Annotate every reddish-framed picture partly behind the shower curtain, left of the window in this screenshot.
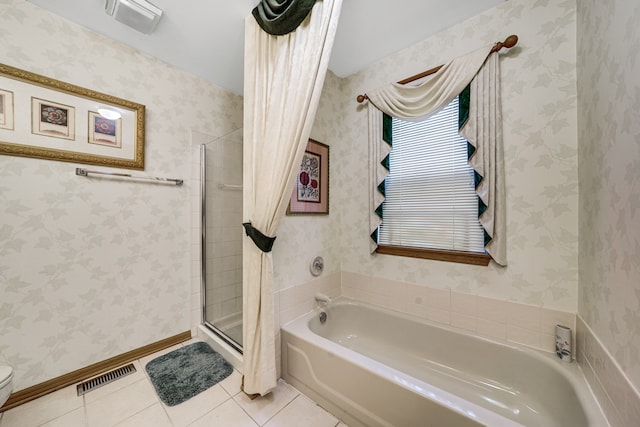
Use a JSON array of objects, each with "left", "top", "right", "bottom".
[{"left": 287, "top": 139, "right": 329, "bottom": 215}]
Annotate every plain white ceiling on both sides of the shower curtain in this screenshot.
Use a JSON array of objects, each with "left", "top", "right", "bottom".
[{"left": 29, "top": 0, "right": 506, "bottom": 94}]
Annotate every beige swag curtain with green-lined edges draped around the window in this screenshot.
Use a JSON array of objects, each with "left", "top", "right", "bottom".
[{"left": 367, "top": 45, "right": 506, "bottom": 265}]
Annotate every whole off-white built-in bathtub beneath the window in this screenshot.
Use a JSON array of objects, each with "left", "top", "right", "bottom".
[{"left": 282, "top": 298, "right": 608, "bottom": 427}]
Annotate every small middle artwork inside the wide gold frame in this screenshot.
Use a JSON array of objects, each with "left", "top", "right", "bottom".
[{"left": 31, "top": 97, "right": 76, "bottom": 141}]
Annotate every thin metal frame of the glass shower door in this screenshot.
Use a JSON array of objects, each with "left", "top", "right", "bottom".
[{"left": 200, "top": 144, "right": 243, "bottom": 354}]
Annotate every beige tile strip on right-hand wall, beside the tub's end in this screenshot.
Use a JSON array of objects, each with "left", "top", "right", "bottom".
[{"left": 576, "top": 316, "right": 640, "bottom": 427}]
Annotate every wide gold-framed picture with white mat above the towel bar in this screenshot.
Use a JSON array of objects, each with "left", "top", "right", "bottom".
[{"left": 0, "top": 64, "right": 145, "bottom": 170}]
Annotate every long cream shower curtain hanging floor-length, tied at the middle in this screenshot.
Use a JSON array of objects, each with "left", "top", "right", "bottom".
[{"left": 243, "top": 0, "right": 342, "bottom": 395}]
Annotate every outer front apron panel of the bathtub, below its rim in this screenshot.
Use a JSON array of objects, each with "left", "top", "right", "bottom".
[{"left": 282, "top": 331, "right": 488, "bottom": 427}]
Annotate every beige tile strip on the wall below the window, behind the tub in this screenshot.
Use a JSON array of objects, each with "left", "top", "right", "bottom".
[{"left": 341, "top": 272, "right": 576, "bottom": 352}]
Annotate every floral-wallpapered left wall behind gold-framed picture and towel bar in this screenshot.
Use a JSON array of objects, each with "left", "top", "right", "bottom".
[{"left": 0, "top": 0, "right": 242, "bottom": 390}]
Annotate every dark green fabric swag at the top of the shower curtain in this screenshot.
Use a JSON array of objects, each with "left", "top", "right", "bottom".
[{"left": 251, "top": 0, "right": 316, "bottom": 36}]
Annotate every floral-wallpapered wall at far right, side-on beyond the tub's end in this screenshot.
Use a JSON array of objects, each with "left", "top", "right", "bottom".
[{"left": 578, "top": 0, "right": 640, "bottom": 394}]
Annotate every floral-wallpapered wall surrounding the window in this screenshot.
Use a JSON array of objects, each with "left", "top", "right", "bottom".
[{"left": 308, "top": 0, "right": 578, "bottom": 312}]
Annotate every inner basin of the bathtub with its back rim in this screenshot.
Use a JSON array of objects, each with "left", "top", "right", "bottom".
[{"left": 283, "top": 298, "right": 606, "bottom": 426}]
